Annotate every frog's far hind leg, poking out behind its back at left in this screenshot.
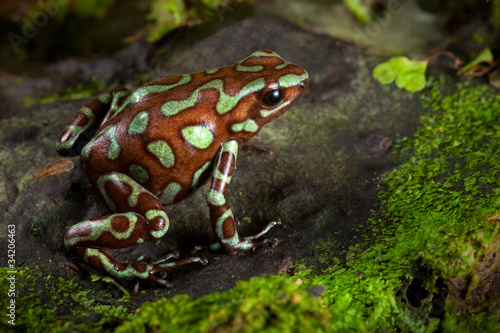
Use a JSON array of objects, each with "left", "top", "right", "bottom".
[{"left": 56, "top": 88, "right": 130, "bottom": 156}]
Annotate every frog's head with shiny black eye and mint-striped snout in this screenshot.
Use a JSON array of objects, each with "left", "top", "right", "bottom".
[{"left": 228, "top": 50, "right": 309, "bottom": 133}]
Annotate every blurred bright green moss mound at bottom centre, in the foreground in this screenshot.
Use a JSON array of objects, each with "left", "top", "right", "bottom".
[{"left": 116, "top": 276, "right": 329, "bottom": 332}]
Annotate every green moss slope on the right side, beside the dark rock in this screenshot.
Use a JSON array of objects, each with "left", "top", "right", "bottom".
[{"left": 299, "top": 77, "right": 500, "bottom": 332}]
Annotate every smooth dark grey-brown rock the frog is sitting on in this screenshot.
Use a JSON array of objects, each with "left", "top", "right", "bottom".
[{"left": 0, "top": 16, "right": 421, "bottom": 303}]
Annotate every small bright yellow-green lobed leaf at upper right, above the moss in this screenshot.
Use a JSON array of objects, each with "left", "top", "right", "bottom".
[{"left": 373, "top": 57, "right": 427, "bottom": 92}]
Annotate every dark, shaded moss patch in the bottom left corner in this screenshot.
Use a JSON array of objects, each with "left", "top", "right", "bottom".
[{"left": 0, "top": 267, "right": 135, "bottom": 332}]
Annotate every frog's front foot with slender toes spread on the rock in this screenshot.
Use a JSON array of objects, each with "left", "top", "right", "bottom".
[{"left": 191, "top": 219, "right": 281, "bottom": 254}]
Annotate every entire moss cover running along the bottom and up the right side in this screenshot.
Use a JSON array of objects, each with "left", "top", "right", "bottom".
[{"left": 1, "top": 79, "right": 500, "bottom": 332}]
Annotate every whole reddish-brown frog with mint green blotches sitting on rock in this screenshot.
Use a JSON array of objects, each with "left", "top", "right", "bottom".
[{"left": 56, "top": 50, "right": 309, "bottom": 287}]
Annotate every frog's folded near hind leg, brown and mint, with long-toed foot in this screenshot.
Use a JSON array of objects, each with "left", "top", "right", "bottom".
[{"left": 64, "top": 172, "right": 206, "bottom": 287}]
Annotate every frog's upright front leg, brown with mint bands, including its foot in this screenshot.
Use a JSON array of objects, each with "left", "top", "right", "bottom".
[{"left": 207, "top": 140, "right": 281, "bottom": 254}]
